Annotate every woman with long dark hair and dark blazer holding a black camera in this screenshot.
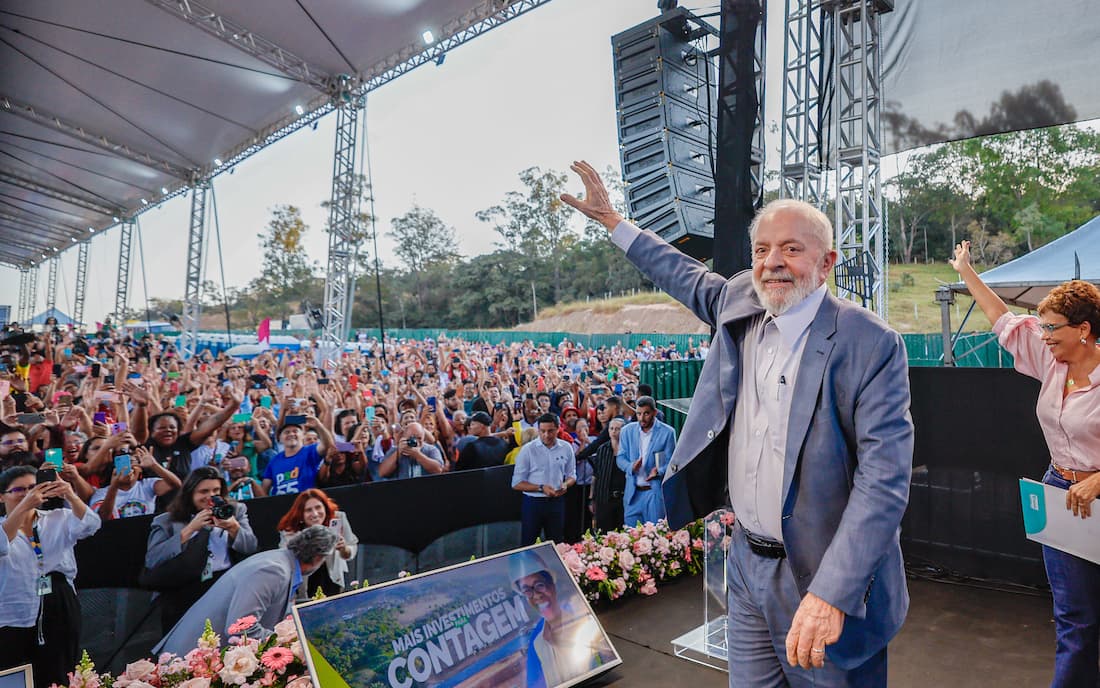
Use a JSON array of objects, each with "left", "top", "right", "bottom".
[{"left": 142, "top": 466, "right": 257, "bottom": 633}]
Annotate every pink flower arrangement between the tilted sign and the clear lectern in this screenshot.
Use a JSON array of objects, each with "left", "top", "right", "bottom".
[{"left": 558, "top": 518, "right": 705, "bottom": 601}]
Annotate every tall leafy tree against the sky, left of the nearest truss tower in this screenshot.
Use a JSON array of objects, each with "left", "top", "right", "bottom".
[{"left": 251, "top": 205, "right": 316, "bottom": 318}]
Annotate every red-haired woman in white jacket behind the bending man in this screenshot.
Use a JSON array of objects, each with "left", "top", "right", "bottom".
[{"left": 278, "top": 488, "right": 359, "bottom": 600}]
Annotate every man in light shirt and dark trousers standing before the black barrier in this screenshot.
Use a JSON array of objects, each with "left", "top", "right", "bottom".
[{"left": 512, "top": 413, "right": 576, "bottom": 546}]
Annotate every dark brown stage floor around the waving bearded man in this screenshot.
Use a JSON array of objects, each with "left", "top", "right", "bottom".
[{"left": 592, "top": 577, "right": 1054, "bottom": 688}]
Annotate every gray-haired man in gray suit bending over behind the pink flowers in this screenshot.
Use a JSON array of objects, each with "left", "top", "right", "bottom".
[{"left": 153, "top": 525, "right": 337, "bottom": 657}]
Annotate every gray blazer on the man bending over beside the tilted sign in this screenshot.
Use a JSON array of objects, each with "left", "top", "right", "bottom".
[{"left": 153, "top": 549, "right": 298, "bottom": 657}]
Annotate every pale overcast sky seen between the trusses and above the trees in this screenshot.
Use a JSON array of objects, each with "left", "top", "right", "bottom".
[{"left": 0, "top": 0, "right": 818, "bottom": 323}]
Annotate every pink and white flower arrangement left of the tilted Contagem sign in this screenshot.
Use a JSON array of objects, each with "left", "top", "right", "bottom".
[{"left": 52, "top": 615, "right": 314, "bottom": 688}]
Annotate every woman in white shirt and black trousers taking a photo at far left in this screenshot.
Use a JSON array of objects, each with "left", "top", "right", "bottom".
[{"left": 0, "top": 466, "right": 100, "bottom": 688}]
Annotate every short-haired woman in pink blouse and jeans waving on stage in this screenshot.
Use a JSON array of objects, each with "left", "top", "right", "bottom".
[{"left": 950, "top": 241, "right": 1100, "bottom": 687}]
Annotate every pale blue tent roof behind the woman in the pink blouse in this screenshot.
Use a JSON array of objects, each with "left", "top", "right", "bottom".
[{"left": 950, "top": 216, "right": 1100, "bottom": 308}]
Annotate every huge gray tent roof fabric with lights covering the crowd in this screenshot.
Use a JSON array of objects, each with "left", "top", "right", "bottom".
[{"left": 0, "top": 0, "right": 549, "bottom": 266}]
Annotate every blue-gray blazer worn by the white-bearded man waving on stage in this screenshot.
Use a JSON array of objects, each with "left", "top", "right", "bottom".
[{"left": 627, "top": 224, "right": 913, "bottom": 668}]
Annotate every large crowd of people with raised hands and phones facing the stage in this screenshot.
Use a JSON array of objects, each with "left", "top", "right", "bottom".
[{"left": 0, "top": 326, "right": 706, "bottom": 685}]
